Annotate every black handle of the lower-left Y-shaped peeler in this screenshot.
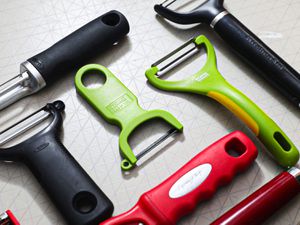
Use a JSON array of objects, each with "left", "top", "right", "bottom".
[{"left": 24, "top": 135, "right": 113, "bottom": 225}]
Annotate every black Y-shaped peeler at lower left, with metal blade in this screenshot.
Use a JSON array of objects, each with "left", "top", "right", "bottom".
[{"left": 0, "top": 101, "right": 113, "bottom": 225}]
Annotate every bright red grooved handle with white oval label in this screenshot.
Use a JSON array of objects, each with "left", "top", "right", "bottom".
[{"left": 147, "top": 132, "right": 257, "bottom": 224}]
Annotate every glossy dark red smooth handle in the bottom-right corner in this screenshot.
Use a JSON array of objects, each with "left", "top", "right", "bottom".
[{"left": 211, "top": 172, "right": 300, "bottom": 225}]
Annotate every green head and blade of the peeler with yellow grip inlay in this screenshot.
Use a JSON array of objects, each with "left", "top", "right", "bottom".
[{"left": 146, "top": 35, "right": 224, "bottom": 95}]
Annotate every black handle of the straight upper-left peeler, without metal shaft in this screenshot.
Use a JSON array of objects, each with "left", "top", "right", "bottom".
[{"left": 27, "top": 10, "right": 129, "bottom": 84}]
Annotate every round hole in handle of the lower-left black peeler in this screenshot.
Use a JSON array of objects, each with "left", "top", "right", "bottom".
[{"left": 73, "top": 191, "right": 97, "bottom": 214}]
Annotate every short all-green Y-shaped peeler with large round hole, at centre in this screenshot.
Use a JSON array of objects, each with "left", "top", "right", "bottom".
[{"left": 75, "top": 64, "right": 183, "bottom": 171}]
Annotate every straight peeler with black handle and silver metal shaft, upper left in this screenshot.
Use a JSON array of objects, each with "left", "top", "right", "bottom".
[{"left": 0, "top": 10, "right": 129, "bottom": 110}]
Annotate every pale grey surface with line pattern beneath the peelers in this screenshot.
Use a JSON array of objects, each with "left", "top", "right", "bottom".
[{"left": 0, "top": 0, "right": 300, "bottom": 225}]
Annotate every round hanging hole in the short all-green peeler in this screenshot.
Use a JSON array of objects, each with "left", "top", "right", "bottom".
[{"left": 81, "top": 70, "right": 106, "bottom": 88}]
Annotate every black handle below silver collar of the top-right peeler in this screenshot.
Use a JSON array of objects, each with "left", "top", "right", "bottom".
[{"left": 214, "top": 14, "right": 300, "bottom": 107}]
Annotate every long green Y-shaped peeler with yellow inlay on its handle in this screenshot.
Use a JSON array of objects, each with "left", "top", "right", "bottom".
[{"left": 146, "top": 35, "right": 299, "bottom": 167}]
